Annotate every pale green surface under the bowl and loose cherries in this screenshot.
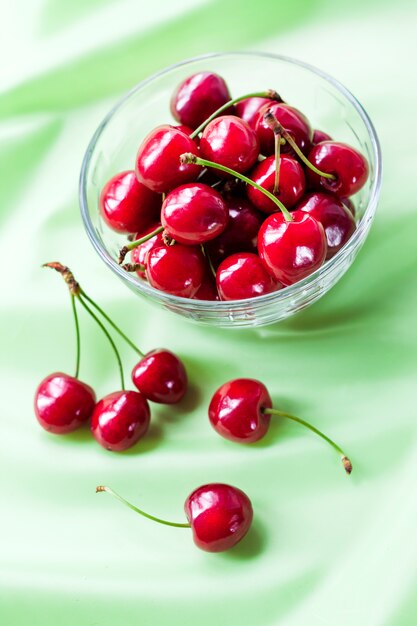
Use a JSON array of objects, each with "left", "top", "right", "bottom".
[{"left": 0, "top": 0, "right": 417, "bottom": 626}]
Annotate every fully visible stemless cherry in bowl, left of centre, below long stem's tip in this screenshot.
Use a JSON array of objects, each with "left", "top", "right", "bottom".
[{"left": 161, "top": 183, "right": 229, "bottom": 245}]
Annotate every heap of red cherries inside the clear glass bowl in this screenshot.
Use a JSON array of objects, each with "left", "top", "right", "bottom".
[{"left": 99, "top": 72, "right": 368, "bottom": 300}]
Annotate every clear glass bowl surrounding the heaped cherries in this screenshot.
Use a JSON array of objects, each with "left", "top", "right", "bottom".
[{"left": 80, "top": 52, "right": 381, "bottom": 328}]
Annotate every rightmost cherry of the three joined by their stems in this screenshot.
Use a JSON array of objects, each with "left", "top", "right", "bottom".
[{"left": 132, "top": 349, "right": 188, "bottom": 404}]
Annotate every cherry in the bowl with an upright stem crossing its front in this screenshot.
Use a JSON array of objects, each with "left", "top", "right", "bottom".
[{"left": 246, "top": 154, "right": 306, "bottom": 213}]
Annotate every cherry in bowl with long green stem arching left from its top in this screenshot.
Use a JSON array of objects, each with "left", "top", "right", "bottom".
[{"left": 258, "top": 211, "right": 327, "bottom": 285}]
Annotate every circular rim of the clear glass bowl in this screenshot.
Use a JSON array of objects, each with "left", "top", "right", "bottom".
[{"left": 79, "top": 51, "right": 382, "bottom": 313}]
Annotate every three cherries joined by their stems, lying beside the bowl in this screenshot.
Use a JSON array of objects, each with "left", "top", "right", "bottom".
[{"left": 35, "top": 262, "right": 188, "bottom": 451}]
